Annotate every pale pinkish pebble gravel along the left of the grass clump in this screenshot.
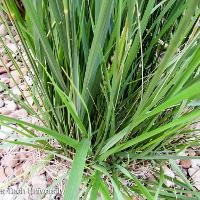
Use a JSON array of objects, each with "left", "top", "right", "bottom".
[{"left": 0, "top": 20, "right": 67, "bottom": 200}]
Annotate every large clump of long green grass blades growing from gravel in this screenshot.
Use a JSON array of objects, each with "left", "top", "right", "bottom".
[{"left": 0, "top": 0, "right": 200, "bottom": 200}]
